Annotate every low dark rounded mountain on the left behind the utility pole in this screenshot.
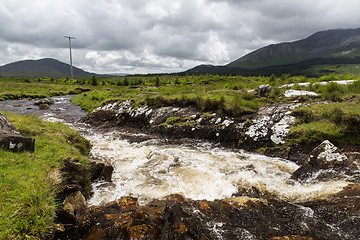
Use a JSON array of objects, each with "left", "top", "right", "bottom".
[{"left": 0, "top": 58, "right": 103, "bottom": 78}]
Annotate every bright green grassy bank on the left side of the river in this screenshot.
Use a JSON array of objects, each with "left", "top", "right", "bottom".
[{"left": 0, "top": 113, "right": 90, "bottom": 239}]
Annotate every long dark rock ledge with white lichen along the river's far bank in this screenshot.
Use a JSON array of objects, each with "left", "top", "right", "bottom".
[{"left": 83, "top": 101, "right": 299, "bottom": 150}]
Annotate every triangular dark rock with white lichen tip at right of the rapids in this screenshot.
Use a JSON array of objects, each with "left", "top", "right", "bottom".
[{"left": 291, "top": 140, "right": 359, "bottom": 181}]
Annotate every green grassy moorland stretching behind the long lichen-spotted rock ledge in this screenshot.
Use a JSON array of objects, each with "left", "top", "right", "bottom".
[{"left": 73, "top": 75, "right": 359, "bottom": 115}]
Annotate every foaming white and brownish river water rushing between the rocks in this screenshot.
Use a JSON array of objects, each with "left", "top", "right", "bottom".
[{"left": 0, "top": 96, "right": 348, "bottom": 205}]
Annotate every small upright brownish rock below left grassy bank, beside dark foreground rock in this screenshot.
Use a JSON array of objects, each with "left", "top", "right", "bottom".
[{"left": 59, "top": 191, "right": 88, "bottom": 223}]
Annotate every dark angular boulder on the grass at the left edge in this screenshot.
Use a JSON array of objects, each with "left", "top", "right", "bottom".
[{"left": 0, "top": 113, "right": 35, "bottom": 152}]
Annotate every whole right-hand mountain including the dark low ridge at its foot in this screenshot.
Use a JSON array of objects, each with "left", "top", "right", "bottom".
[{"left": 188, "top": 28, "right": 360, "bottom": 74}]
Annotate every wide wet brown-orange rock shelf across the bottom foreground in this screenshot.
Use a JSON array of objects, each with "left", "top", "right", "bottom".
[{"left": 57, "top": 191, "right": 360, "bottom": 240}]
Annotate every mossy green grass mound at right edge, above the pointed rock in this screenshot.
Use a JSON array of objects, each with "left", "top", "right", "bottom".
[{"left": 288, "top": 101, "right": 360, "bottom": 145}]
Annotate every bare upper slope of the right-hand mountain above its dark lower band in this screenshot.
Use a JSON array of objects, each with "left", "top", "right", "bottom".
[{"left": 226, "top": 28, "right": 360, "bottom": 69}]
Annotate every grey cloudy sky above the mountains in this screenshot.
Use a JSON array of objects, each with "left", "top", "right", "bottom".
[{"left": 0, "top": 0, "right": 360, "bottom": 73}]
